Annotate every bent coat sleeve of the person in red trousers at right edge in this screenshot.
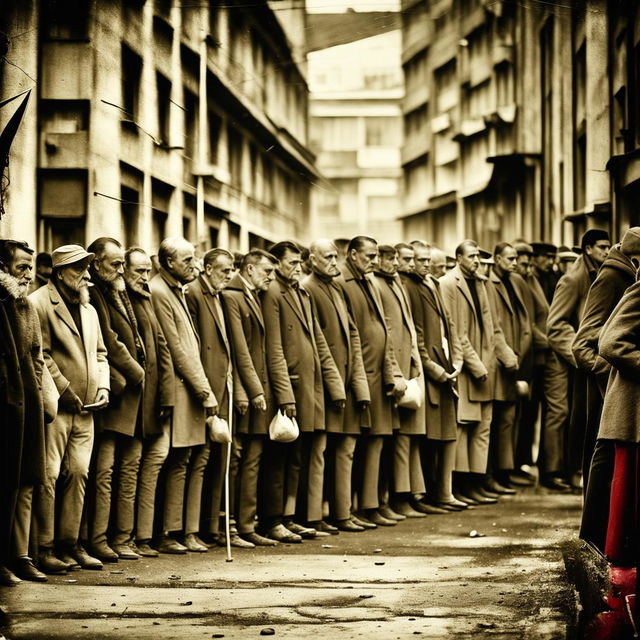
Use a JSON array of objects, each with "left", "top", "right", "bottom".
[{"left": 598, "top": 284, "right": 640, "bottom": 379}]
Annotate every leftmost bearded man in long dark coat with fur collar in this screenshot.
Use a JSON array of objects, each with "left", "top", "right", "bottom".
[{"left": 0, "top": 240, "right": 47, "bottom": 586}]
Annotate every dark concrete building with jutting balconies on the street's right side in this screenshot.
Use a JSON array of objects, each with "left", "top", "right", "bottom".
[{"left": 402, "top": 0, "right": 640, "bottom": 249}]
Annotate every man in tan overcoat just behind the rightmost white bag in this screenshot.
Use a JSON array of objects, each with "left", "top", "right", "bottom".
[{"left": 370, "top": 245, "right": 426, "bottom": 518}]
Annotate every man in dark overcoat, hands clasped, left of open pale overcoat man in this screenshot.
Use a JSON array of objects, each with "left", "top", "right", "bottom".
[{"left": 401, "top": 241, "right": 463, "bottom": 513}]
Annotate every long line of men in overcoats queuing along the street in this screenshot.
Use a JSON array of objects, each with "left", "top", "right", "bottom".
[{"left": 0, "top": 230, "right": 626, "bottom": 585}]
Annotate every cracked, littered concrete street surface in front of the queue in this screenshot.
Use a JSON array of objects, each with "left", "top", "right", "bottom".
[{"left": 0, "top": 489, "right": 581, "bottom": 640}]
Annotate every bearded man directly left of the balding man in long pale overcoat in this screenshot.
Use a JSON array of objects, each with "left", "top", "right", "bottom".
[{"left": 124, "top": 247, "right": 175, "bottom": 558}]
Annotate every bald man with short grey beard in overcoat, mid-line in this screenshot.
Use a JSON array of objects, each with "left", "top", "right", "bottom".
[{"left": 302, "top": 240, "right": 370, "bottom": 531}]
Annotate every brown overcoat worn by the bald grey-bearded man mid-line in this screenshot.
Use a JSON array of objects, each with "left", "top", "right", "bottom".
[{"left": 302, "top": 273, "right": 371, "bottom": 435}]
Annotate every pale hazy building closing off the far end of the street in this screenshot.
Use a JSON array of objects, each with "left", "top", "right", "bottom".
[{"left": 308, "top": 12, "right": 403, "bottom": 242}]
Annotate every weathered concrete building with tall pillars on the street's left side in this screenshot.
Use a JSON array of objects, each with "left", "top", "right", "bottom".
[{"left": 0, "top": 0, "right": 316, "bottom": 252}]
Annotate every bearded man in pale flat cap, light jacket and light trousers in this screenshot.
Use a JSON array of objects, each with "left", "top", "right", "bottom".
[{"left": 29, "top": 245, "right": 109, "bottom": 573}]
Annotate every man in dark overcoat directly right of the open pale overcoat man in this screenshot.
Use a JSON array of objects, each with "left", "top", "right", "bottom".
[{"left": 488, "top": 242, "right": 533, "bottom": 490}]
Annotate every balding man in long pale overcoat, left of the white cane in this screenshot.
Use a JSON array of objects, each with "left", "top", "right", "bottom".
[{"left": 150, "top": 238, "right": 218, "bottom": 553}]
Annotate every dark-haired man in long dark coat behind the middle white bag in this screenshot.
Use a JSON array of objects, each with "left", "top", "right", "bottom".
[{"left": 262, "top": 241, "right": 346, "bottom": 540}]
